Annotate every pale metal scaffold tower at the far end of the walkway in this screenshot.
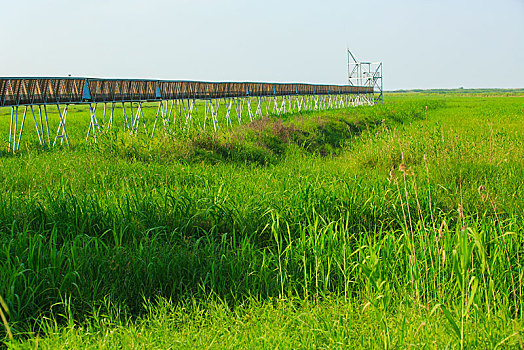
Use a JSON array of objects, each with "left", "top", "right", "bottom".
[{"left": 347, "top": 49, "right": 384, "bottom": 104}]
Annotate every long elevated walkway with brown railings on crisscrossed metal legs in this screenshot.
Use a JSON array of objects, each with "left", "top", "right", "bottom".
[{"left": 0, "top": 78, "right": 376, "bottom": 152}]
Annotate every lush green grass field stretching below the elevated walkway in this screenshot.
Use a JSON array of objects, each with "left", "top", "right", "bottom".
[{"left": 0, "top": 93, "right": 524, "bottom": 349}]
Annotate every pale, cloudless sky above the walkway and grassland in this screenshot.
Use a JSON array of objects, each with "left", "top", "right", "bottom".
[{"left": 0, "top": 0, "right": 524, "bottom": 90}]
